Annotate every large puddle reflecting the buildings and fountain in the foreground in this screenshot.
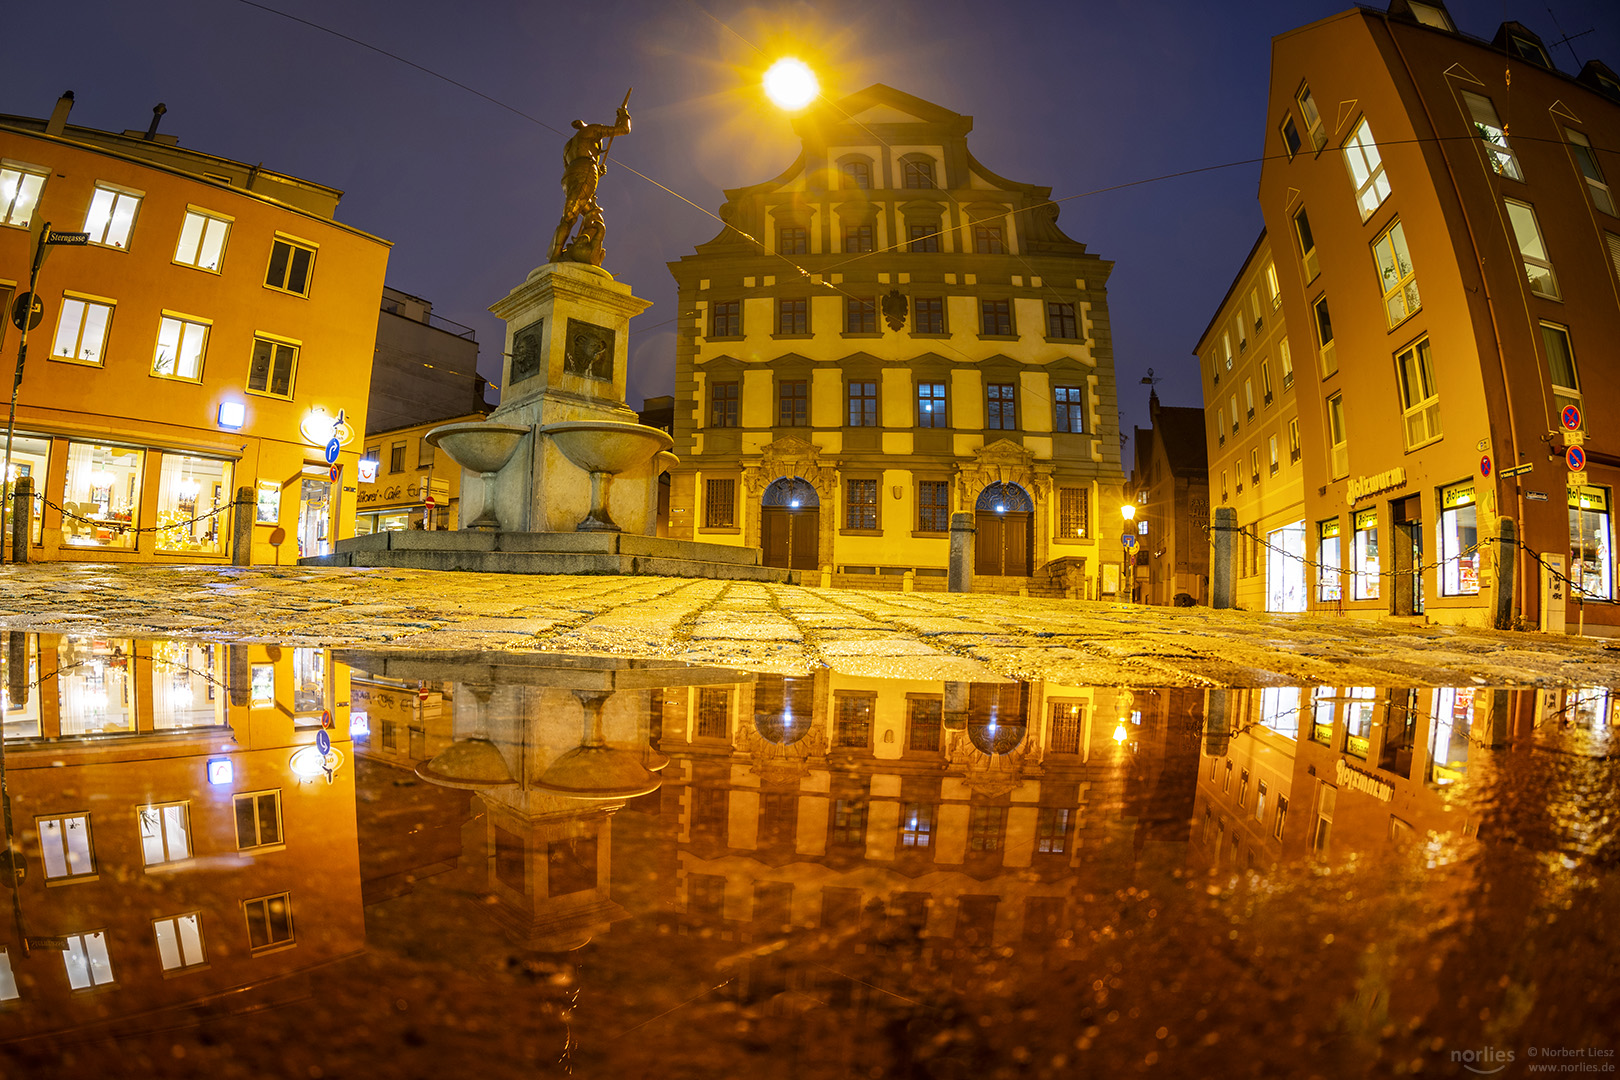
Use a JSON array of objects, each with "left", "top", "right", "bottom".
[{"left": 0, "top": 633, "right": 1620, "bottom": 1080}]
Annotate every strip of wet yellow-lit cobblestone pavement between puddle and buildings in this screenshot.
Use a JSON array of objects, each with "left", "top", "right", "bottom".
[{"left": 0, "top": 563, "right": 1620, "bottom": 687}]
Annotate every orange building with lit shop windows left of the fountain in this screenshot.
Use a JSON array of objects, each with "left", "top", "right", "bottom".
[{"left": 0, "top": 96, "right": 389, "bottom": 563}]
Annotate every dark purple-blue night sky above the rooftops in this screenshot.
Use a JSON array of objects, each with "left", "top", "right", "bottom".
[{"left": 0, "top": 0, "right": 1620, "bottom": 453}]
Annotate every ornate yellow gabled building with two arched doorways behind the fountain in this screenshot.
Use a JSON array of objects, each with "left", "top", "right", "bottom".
[{"left": 669, "top": 86, "right": 1124, "bottom": 596}]
